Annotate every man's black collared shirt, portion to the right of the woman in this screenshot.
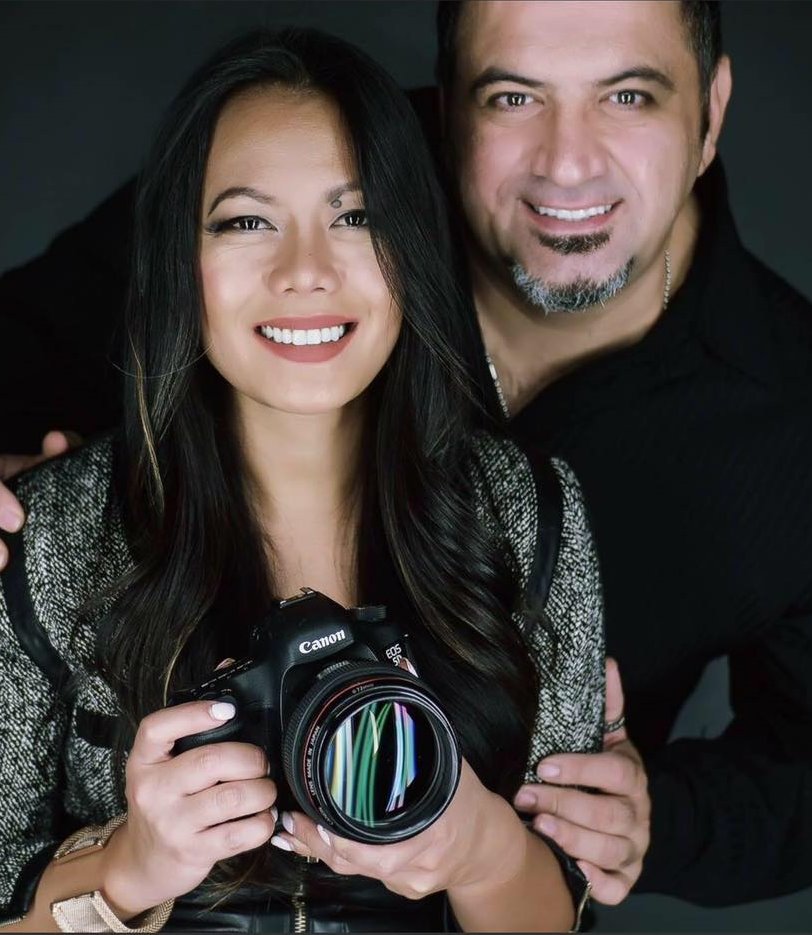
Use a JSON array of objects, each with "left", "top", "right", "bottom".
[{"left": 504, "top": 166, "right": 812, "bottom": 905}]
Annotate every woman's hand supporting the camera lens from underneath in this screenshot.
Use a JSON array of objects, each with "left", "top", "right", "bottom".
[{"left": 272, "top": 761, "right": 529, "bottom": 900}]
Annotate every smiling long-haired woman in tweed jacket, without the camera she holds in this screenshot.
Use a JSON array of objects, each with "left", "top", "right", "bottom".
[{"left": 0, "top": 32, "right": 603, "bottom": 931}]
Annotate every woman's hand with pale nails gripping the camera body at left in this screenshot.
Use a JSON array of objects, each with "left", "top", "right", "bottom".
[{"left": 102, "top": 701, "right": 276, "bottom": 918}]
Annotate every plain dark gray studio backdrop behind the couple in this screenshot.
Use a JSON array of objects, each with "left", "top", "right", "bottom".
[{"left": 0, "top": 0, "right": 812, "bottom": 932}]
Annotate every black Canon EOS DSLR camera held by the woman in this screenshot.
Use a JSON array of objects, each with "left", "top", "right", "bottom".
[{"left": 170, "top": 588, "right": 461, "bottom": 844}]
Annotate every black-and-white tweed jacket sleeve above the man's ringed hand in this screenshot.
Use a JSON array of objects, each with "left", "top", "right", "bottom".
[{"left": 473, "top": 432, "right": 604, "bottom": 768}]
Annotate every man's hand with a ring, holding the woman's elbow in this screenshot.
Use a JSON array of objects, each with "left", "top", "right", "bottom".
[{"left": 514, "top": 659, "right": 651, "bottom": 906}]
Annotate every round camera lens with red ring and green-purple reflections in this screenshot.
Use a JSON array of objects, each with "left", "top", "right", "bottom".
[{"left": 283, "top": 662, "right": 460, "bottom": 844}]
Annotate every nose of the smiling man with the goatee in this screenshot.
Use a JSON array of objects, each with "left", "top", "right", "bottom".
[{"left": 532, "top": 107, "right": 606, "bottom": 188}]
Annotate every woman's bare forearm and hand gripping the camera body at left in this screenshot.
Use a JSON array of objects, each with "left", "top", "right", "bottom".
[{"left": 3, "top": 701, "right": 276, "bottom": 932}]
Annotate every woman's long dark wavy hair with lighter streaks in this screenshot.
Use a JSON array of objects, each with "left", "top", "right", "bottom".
[{"left": 100, "top": 30, "right": 537, "bottom": 892}]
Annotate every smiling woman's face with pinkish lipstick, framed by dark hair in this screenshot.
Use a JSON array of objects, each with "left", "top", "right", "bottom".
[{"left": 200, "top": 88, "right": 401, "bottom": 414}]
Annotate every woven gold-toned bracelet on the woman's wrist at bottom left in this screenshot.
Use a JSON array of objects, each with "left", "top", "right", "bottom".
[{"left": 51, "top": 814, "right": 175, "bottom": 933}]
